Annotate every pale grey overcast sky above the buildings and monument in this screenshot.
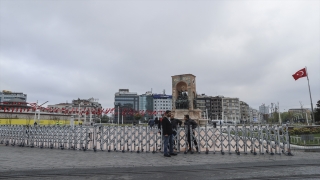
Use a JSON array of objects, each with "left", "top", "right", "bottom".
[{"left": 0, "top": 0, "right": 320, "bottom": 111}]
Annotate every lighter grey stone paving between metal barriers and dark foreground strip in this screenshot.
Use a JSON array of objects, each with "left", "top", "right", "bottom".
[{"left": 0, "top": 145, "right": 320, "bottom": 172}]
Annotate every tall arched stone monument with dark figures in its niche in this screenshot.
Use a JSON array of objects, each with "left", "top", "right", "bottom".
[{"left": 171, "top": 74, "right": 207, "bottom": 125}]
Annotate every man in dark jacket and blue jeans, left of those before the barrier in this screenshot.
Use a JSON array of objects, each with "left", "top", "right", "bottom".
[{"left": 162, "top": 110, "right": 177, "bottom": 157}]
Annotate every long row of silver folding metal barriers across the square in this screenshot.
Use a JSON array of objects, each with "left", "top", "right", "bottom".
[{"left": 0, "top": 125, "right": 291, "bottom": 155}]
